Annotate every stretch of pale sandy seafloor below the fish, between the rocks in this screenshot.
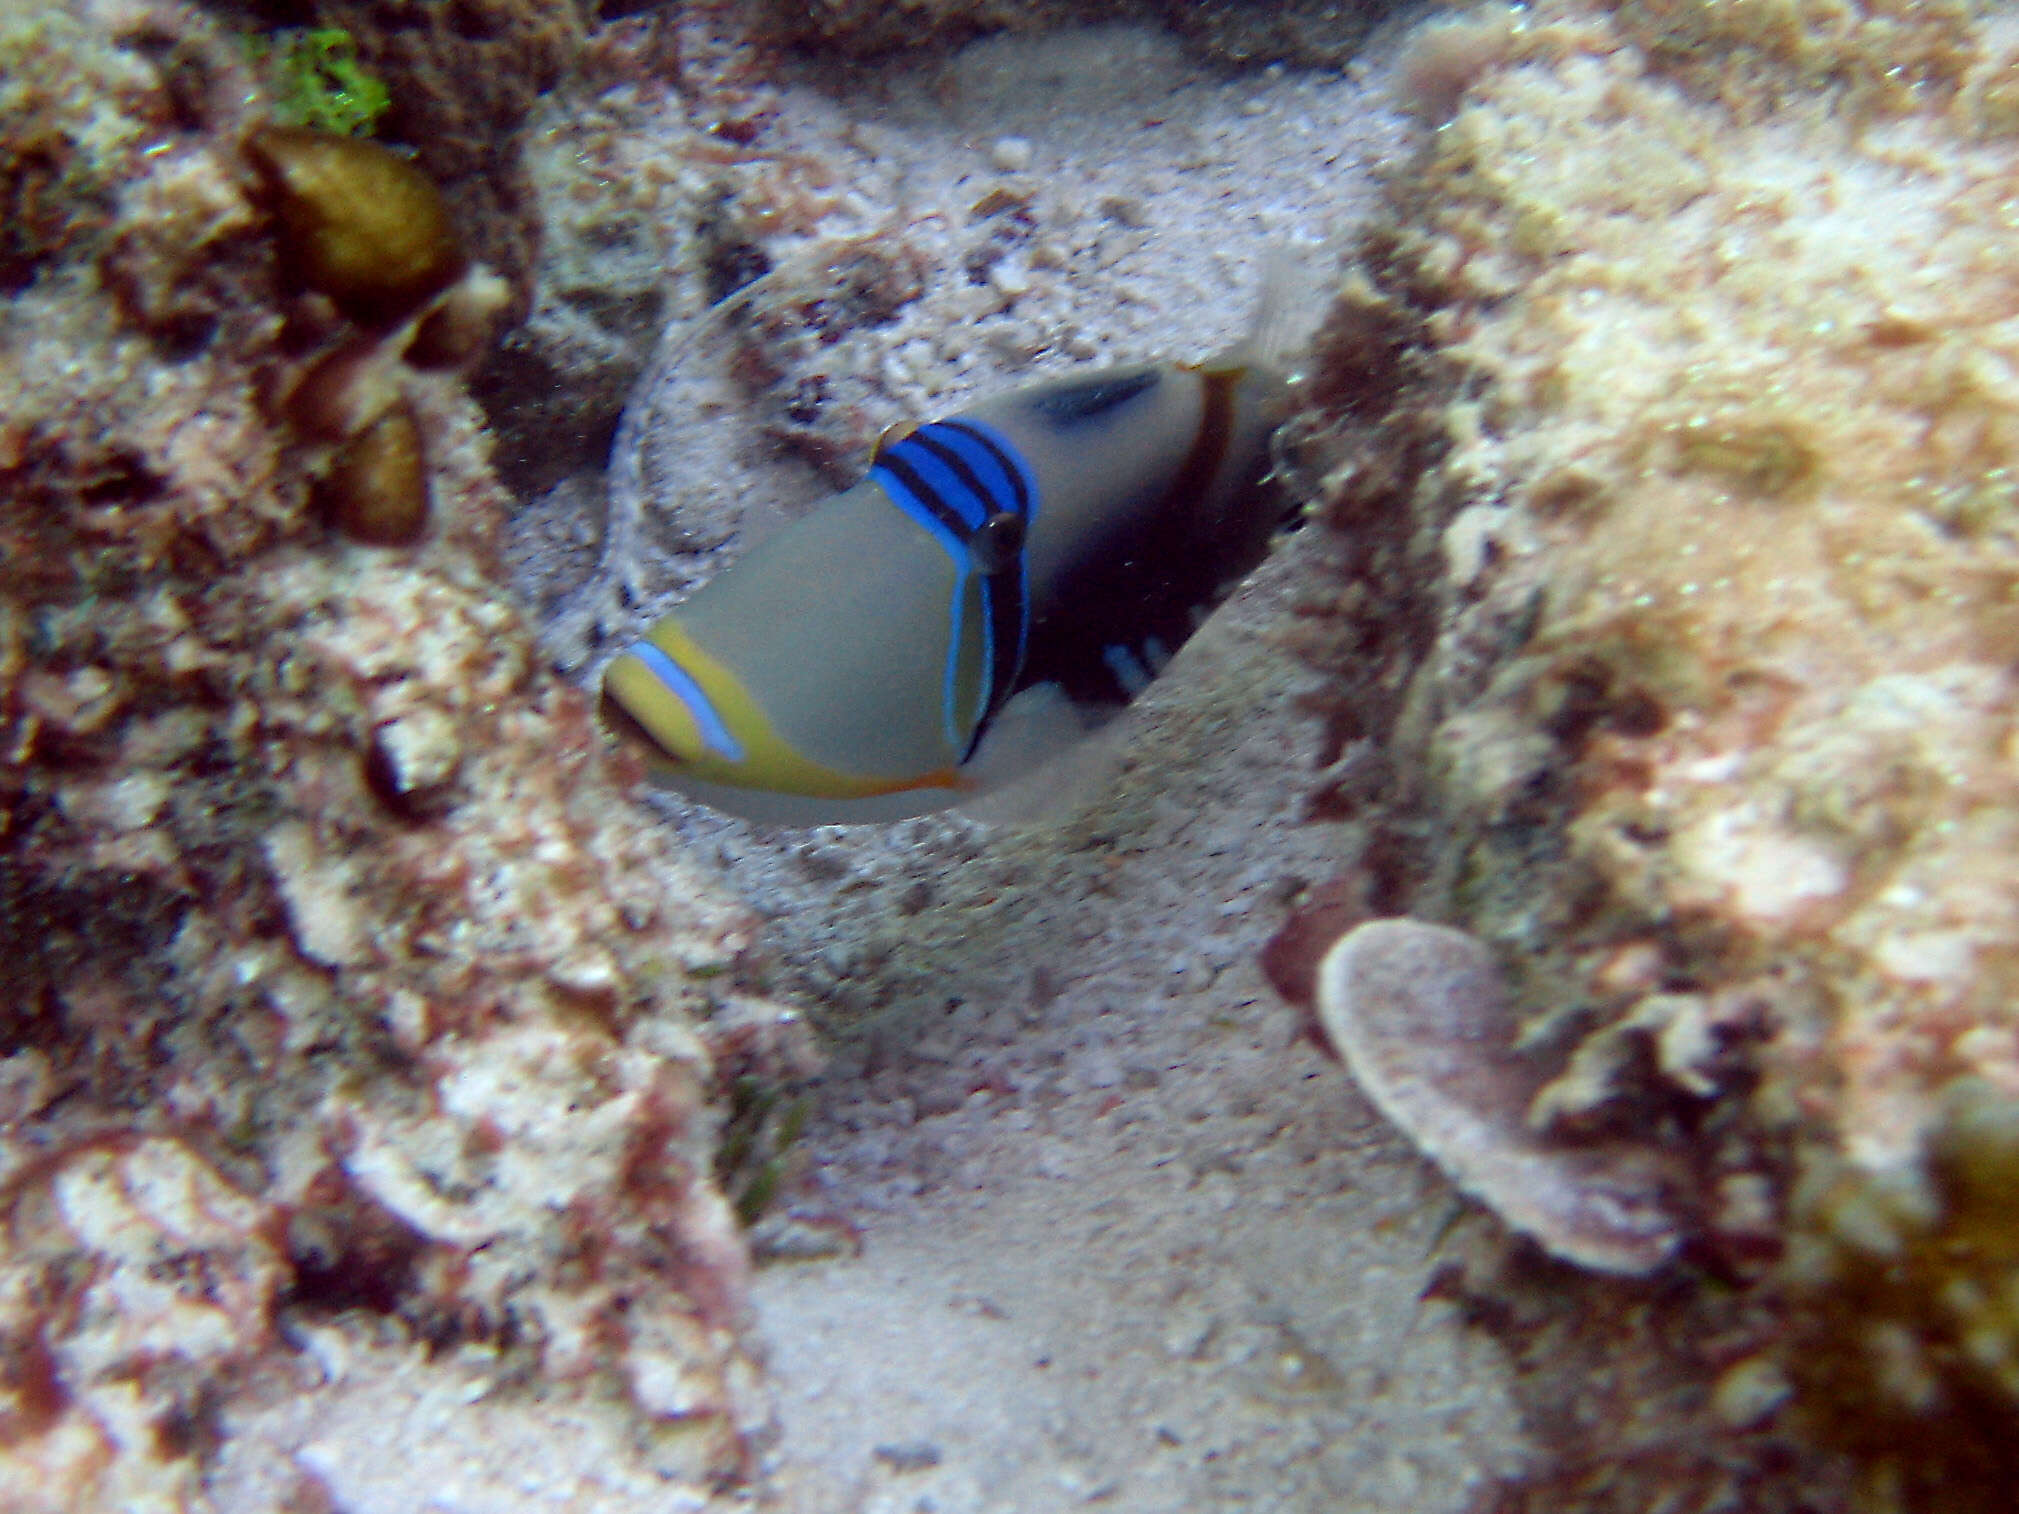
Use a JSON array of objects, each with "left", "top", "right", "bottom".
[{"left": 735, "top": 569, "right": 1518, "bottom": 1510}]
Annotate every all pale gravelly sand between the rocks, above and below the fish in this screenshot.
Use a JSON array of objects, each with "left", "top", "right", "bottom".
[{"left": 517, "top": 30, "right": 1524, "bottom": 1514}]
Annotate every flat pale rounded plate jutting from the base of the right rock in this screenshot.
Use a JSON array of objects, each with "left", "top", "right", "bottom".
[{"left": 1318, "top": 918, "right": 1682, "bottom": 1276}]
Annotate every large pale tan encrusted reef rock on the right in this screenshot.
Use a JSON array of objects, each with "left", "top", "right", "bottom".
[{"left": 1300, "top": 0, "right": 2019, "bottom": 1510}]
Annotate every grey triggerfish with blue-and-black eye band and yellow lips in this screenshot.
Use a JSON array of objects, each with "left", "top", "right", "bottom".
[{"left": 604, "top": 299, "right": 1286, "bottom": 826}]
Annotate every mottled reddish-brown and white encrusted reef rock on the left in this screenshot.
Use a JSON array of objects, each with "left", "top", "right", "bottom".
[{"left": 0, "top": 0, "right": 798, "bottom": 1510}]
